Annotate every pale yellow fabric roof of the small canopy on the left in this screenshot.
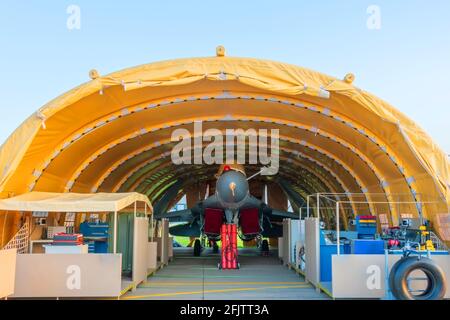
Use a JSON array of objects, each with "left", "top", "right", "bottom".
[{"left": 0, "top": 192, "right": 152, "bottom": 214}]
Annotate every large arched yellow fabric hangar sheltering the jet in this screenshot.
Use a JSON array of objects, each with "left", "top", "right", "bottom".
[{"left": 0, "top": 49, "right": 450, "bottom": 245}]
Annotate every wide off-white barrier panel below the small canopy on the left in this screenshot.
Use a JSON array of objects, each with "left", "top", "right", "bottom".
[{"left": 12, "top": 254, "right": 122, "bottom": 298}]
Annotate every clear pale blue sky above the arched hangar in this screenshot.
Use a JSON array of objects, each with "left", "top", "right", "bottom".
[{"left": 0, "top": 0, "right": 450, "bottom": 153}]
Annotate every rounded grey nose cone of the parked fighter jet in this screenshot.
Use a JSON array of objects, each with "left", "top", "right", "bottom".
[{"left": 216, "top": 171, "right": 248, "bottom": 207}]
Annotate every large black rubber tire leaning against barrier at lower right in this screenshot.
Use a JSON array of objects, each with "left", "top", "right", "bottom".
[{"left": 389, "top": 257, "right": 447, "bottom": 300}]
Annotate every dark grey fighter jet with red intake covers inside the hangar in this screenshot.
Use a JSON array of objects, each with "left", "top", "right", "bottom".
[{"left": 155, "top": 165, "right": 299, "bottom": 256}]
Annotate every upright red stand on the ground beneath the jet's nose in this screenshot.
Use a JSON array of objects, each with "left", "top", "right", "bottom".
[{"left": 219, "top": 224, "right": 239, "bottom": 269}]
